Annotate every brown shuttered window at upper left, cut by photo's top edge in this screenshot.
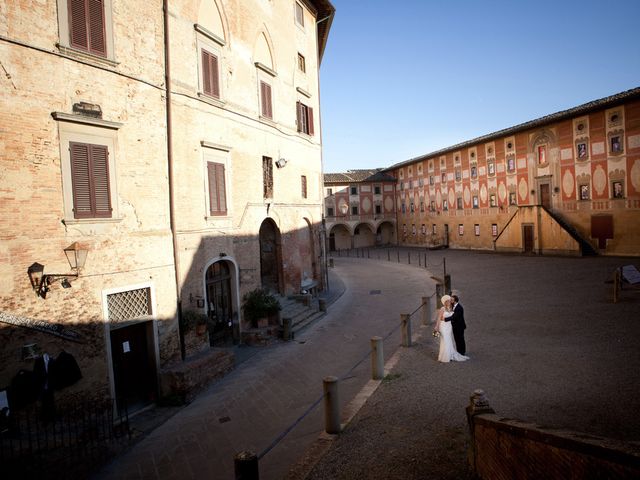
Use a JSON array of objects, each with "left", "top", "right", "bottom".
[{"left": 67, "top": 0, "right": 107, "bottom": 57}]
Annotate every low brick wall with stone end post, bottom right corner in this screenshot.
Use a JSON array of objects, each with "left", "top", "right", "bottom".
[{"left": 467, "top": 391, "right": 640, "bottom": 480}]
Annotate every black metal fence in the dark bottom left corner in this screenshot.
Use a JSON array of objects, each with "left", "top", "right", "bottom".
[{"left": 0, "top": 399, "right": 131, "bottom": 479}]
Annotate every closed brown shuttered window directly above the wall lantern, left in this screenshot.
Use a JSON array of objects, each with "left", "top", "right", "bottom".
[{"left": 69, "top": 142, "right": 111, "bottom": 218}]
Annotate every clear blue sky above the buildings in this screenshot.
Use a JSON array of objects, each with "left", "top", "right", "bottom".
[{"left": 320, "top": 0, "right": 640, "bottom": 173}]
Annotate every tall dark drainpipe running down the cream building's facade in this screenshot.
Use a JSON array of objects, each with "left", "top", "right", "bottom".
[{"left": 162, "top": 0, "right": 185, "bottom": 360}]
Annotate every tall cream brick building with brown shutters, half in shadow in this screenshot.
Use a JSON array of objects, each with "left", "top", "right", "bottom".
[{"left": 0, "top": 0, "right": 334, "bottom": 408}]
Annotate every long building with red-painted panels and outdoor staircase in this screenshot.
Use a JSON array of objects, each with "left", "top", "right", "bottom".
[{"left": 384, "top": 88, "right": 640, "bottom": 255}]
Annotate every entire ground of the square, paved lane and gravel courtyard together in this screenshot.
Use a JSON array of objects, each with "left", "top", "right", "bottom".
[{"left": 97, "top": 250, "right": 640, "bottom": 480}]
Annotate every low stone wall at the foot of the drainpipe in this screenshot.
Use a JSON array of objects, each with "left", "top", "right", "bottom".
[{"left": 160, "top": 349, "right": 235, "bottom": 403}]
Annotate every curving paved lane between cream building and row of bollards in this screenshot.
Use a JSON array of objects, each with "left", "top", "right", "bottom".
[{"left": 96, "top": 255, "right": 434, "bottom": 480}]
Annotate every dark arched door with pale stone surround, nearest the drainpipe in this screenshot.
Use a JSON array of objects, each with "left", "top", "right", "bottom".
[{"left": 205, "top": 261, "right": 234, "bottom": 346}]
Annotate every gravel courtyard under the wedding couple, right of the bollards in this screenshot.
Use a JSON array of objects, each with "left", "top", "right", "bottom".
[{"left": 302, "top": 251, "right": 640, "bottom": 480}]
